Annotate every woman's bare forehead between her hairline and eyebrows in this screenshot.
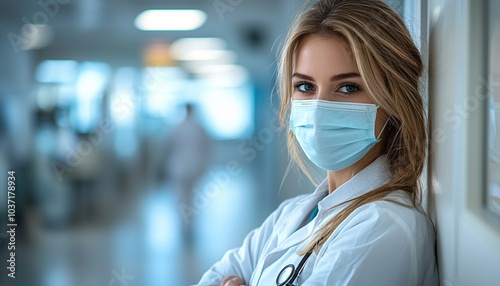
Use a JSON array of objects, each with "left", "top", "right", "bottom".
[{"left": 294, "top": 34, "right": 358, "bottom": 77}]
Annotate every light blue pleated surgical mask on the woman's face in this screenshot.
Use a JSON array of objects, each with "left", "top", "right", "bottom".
[{"left": 290, "top": 100, "right": 387, "bottom": 171}]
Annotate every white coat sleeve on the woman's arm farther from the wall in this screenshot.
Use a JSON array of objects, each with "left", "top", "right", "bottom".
[{"left": 197, "top": 197, "right": 296, "bottom": 286}]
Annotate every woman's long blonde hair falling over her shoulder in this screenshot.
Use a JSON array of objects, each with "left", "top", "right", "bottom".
[{"left": 278, "top": 0, "right": 427, "bottom": 254}]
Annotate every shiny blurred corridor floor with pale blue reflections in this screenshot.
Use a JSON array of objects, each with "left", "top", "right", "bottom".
[{"left": 2, "top": 167, "right": 265, "bottom": 286}]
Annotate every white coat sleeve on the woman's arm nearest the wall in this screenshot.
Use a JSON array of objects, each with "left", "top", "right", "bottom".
[{"left": 301, "top": 203, "right": 438, "bottom": 286}]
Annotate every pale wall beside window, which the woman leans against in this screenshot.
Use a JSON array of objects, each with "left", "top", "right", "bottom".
[{"left": 427, "top": 0, "right": 500, "bottom": 285}]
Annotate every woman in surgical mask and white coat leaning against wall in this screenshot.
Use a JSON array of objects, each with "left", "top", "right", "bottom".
[{"left": 199, "top": 0, "right": 439, "bottom": 285}]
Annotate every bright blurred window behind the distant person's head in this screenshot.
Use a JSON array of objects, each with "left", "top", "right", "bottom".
[{"left": 143, "top": 65, "right": 254, "bottom": 140}]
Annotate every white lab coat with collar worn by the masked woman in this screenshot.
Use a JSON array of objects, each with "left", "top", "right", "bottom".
[{"left": 198, "top": 156, "right": 439, "bottom": 286}]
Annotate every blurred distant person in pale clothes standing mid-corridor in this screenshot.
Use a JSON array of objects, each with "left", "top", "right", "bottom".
[{"left": 166, "top": 103, "right": 211, "bottom": 243}]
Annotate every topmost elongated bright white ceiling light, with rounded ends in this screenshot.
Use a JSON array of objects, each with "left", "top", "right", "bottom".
[{"left": 135, "top": 9, "right": 207, "bottom": 31}]
